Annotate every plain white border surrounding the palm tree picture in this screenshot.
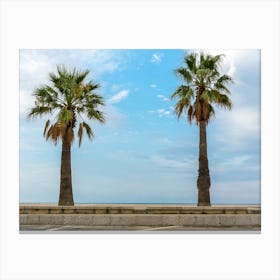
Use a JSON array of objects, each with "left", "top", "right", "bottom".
[{"left": 0, "top": 0, "right": 280, "bottom": 280}]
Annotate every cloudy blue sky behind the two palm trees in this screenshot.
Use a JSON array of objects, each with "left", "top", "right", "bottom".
[{"left": 19, "top": 49, "right": 261, "bottom": 204}]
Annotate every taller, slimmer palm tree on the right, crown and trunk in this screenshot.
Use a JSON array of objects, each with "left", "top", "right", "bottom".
[{"left": 171, "top": 53, "right": 233, "bottom": 206}]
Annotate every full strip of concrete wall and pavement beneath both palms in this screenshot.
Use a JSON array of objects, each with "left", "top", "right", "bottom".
[{"left": 19, "top": 204, "right": 261, "bottom": 233}]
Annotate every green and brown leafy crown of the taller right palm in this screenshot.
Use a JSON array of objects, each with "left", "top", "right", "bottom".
[{"left": 171, "top": 53, "right": 232, "bottom": 123}]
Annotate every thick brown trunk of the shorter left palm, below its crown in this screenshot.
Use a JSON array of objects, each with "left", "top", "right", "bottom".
[{"left": 58, "top": 140, "right": 74, "bottom": 205}]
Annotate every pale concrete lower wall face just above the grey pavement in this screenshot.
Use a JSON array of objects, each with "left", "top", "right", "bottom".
[{"left": 20, "top": 214, "right": 261, "bottom": 227}]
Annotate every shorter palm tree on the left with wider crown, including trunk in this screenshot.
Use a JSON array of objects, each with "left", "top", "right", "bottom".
[{"left": 28, "top": 67, "right": 105, "bottom": 205}]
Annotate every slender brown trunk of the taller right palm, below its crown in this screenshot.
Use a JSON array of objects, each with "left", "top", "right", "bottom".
[{"left": 197, "top": 121, "right": 211, "bottom": 206}]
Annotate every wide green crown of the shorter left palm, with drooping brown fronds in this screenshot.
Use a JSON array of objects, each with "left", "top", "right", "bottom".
[{"left": 28, "top": 65, "right": 105, "bottom": 146}]
